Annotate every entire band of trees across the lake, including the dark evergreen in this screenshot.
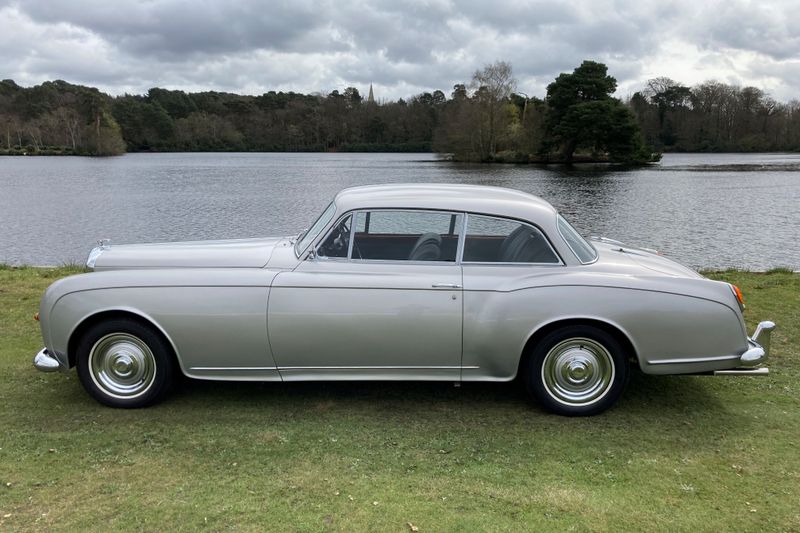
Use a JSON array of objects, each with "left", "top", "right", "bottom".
[{"left": 0, "top": 61, "right": 800, "bottom": 158}]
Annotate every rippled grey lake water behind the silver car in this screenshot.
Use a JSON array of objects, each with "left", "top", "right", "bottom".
[{"left": 0, "top": 153, "right": 800, "bottom": 270}]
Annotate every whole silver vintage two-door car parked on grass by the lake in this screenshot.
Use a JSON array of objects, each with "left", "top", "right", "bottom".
[{"left": 34, "top": 184, "right": 774, "bottom": 415}]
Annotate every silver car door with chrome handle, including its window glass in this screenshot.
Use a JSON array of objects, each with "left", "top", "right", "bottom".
[{"left": 267, "top": 210, "right": 463, "bottom": 380}]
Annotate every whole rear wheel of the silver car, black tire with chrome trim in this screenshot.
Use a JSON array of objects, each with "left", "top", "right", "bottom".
[{"left": 523, "top": 325, "right": 630, "bottom": 416}]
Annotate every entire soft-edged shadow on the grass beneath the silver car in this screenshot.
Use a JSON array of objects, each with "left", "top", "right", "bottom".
[{"left": 29, "top": 370, "right": 757, "bottom": 454}]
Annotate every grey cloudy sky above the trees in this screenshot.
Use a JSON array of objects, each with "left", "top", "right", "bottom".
[{"left": 0, "top": 0, "right": 800, "bottom": 100}]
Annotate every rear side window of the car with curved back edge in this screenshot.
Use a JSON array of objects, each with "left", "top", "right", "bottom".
[{"left": 464, "top": 215, "right": 560, "bottom": 264}]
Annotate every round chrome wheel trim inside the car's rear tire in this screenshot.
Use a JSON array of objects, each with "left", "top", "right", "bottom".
[{"left": 542, "top": 337, "right": 616, "bottom": 407}]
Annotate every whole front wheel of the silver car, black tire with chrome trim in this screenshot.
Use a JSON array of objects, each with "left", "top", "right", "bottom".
[{"left": 76, "top": 318, "right": 175, "bottom": 409}]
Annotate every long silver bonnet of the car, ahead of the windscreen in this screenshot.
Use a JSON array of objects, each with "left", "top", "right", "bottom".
[{"left": 87, "top": 237, "right": 284, "bottom": 270}]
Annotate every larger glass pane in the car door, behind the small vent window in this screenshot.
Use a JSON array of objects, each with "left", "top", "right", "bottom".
[{"left": 351, "top": 210, "right": 463, "bottom": 262}]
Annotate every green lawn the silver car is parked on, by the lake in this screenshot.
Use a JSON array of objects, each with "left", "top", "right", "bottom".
[{"left": 0, "top": 268, "right": 800, "bottom": 531}]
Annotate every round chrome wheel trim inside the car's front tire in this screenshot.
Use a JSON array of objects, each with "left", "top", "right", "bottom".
[{"left": 89, "top": 332, "right": 156, "bottom": 399}]
